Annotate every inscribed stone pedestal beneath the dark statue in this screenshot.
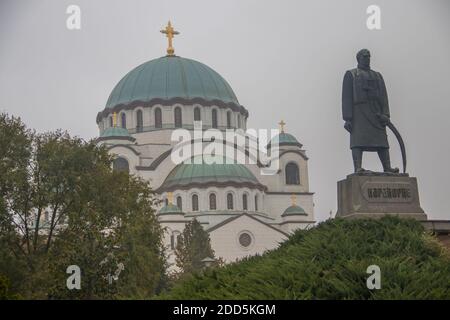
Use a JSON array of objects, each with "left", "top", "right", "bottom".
[{"left": 336, "top": 173, "right": 427, "bottom": 220}]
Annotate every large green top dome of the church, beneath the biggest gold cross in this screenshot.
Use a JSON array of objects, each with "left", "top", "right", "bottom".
[{"left": 106, "top": 56, "right": 239, "bottom": 108}]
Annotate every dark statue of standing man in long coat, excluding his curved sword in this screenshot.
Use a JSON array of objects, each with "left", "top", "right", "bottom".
[{"left": 342, "top": 49, "right": 399, "bottom": 173}]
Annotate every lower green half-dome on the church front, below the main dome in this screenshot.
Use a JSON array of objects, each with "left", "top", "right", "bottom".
[{"left": 159, "top": 155, "right": 265, "bottom": 192}]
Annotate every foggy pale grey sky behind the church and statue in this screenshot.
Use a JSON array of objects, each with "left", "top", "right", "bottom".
[{"left": 0, "top": 0, "right": 450, "bottom": 220}]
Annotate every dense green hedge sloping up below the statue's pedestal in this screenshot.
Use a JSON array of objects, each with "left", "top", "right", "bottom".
[{"left": 160, "top": 217, "right": 450, "bottom": 299}]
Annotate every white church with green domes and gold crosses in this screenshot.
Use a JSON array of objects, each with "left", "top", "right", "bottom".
[{"left": 96, "top": 23, "right": 315, "bottom": 263}]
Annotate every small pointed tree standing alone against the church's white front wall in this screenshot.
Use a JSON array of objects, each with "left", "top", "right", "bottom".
[{"left": 175, "top": 219, "right": 214, "bottom": 274}]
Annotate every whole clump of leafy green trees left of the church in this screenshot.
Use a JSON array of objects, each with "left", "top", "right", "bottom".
[{"left": 0, "top": 114, "right": 165, "bottom": 299}]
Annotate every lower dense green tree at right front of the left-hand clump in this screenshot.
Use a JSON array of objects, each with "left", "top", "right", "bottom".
[{"left": 45, "top": 172, "right": 165, "bottom": 299}]
